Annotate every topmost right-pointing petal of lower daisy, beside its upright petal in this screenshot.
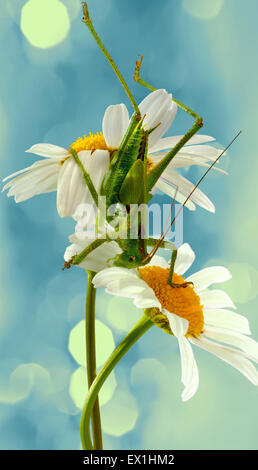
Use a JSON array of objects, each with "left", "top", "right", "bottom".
[{"left": 186, "top": 266, "right": 232, "bottom": 291}]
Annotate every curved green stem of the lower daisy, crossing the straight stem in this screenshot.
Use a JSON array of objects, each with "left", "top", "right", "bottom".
[{"left": 81, "top": 314, "right": 153, "bottom": 450}]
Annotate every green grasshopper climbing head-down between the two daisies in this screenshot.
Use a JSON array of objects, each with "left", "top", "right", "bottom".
[{"left": 68, "top": 2, "right": 206, "bottom": 284}]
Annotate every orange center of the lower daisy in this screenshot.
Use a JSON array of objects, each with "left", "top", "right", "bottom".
[{"left": 139, "top": 266, "right": 204, "bottom": 336}]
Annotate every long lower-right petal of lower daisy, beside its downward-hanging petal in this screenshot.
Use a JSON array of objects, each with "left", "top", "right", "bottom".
[{"left": 190, "top": 336, "right": 258, "bottom": 385}]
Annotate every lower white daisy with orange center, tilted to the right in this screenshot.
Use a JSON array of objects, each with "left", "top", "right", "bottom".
[{"left": 93, "top": 244, "right": 258, "bottom": 401}]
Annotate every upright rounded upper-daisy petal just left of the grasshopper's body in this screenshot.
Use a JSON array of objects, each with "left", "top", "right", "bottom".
[{"left": 102, "top": 104, "right": 129, "bottom": 148}]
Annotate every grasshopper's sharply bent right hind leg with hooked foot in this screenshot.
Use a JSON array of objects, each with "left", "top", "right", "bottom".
[{"left": 133, "top": 56, "right": 203, "bottom": 191}]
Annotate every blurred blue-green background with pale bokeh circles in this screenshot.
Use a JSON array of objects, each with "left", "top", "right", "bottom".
[{"left": 0, "top": 0, "right": 258, "bottom": 449}]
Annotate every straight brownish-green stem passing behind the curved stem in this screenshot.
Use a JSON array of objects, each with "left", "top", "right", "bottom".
[{"left": 85, "top": 271, "right": 103, "bottom": 450}]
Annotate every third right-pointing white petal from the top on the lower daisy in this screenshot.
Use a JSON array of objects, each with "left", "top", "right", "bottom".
[{"left": 203, "top": 309, "right": 251, "bottom": 335}]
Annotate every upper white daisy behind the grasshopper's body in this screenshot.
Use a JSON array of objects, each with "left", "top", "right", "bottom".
[{"left": 3, "top": 89, "right": 222, "bottom": 217}]
